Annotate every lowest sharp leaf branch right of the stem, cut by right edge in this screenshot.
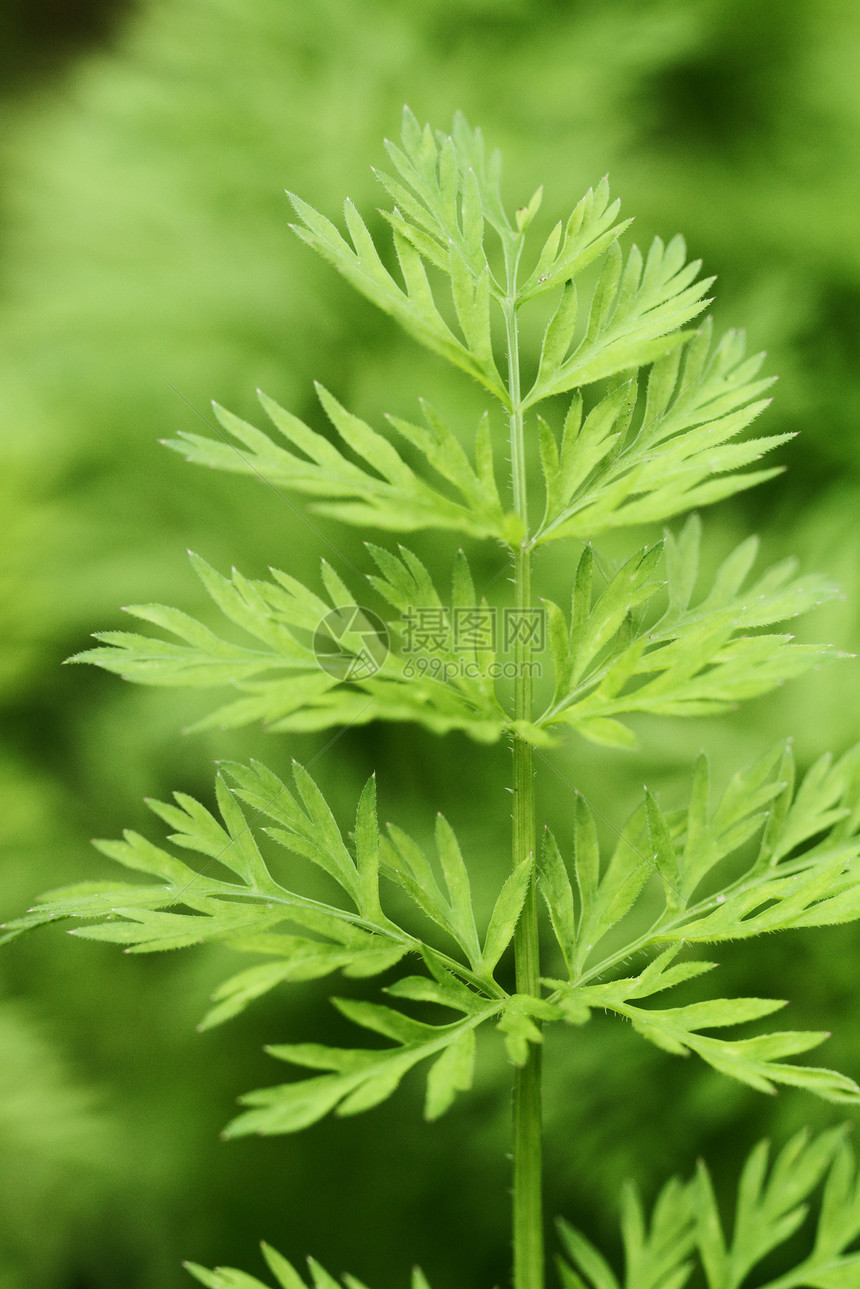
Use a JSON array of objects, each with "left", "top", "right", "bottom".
[{"left": 542, "top": 746, "right": 860, "bottom": 1101}]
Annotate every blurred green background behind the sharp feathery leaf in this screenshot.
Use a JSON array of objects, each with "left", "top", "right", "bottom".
[{"left": 0, "top": 0, "right": 860, "bottom": 1289}]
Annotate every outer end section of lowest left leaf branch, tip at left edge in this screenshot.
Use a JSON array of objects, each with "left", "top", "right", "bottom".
[{"left": 5, "top": 762, "right": 422, "bottom": 1005}]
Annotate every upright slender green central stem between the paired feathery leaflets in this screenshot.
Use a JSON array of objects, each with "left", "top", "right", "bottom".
[{"left": 504, "top": 253, "right": 544, "bottom": 1289}]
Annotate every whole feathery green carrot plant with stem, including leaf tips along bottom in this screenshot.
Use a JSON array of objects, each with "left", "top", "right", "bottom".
[{"left": 6, "top": 112, "right": 860, "bottom": 1289}]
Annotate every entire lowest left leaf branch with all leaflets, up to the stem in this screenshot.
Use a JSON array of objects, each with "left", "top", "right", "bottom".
[{"left": 0, "top": 763, "right": 538, "bottom": 1134}]
